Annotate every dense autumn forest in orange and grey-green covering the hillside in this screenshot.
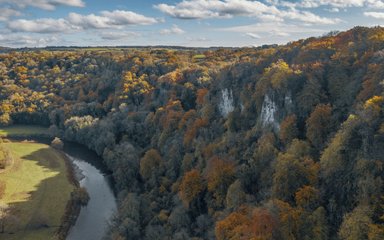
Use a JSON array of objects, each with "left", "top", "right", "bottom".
[{"left": 0, "top": 27, "right": 384, "bottom": 240}]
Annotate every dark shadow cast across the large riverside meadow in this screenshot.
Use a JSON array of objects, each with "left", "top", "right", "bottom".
[{"left": 0, "top": 143, "right": 75, "bottom": 239}]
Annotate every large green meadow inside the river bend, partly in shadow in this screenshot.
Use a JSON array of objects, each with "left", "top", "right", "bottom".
[{"left": 0, "top": 142, "right": 74, "bottom": 240}]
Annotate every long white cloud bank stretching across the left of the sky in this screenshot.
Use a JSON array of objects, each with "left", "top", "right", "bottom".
[{"left": 7, "top": 10, "right": 158, "bottom": 33}]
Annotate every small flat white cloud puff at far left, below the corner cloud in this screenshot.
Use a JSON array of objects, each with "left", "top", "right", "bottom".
[{"left": 8, "top": 18, "right": 75, "bottom": 33}]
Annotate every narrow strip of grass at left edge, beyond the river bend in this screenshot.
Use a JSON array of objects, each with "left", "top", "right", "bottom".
[{"left": 0, "top": 125, "right": 48, "bottom": 137}]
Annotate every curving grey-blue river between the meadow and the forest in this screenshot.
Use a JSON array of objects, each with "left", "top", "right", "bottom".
[{"left": 64, "top": 143, "right": 117, "bottom": 240}]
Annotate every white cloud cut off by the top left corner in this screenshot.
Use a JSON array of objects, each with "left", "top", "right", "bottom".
[{"left": 0, "top": 0, "right": 85, "bottom": 10}]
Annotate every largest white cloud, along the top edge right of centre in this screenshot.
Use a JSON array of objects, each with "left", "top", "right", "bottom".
[{"left": 154, "top": 0, "right": 340, "bottom": 24}]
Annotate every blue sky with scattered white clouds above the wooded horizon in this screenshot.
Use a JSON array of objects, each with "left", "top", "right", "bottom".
[{"left": 0, "top": 0, "right": 384, "bottom": 47}]
